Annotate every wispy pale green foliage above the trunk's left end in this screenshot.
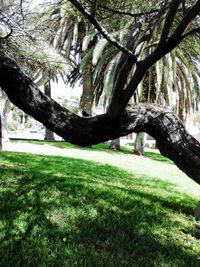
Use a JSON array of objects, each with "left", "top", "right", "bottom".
[{"left": 0, "top": 1, "right": 70, "bottom": 85}]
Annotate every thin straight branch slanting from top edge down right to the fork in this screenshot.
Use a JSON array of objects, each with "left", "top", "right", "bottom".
[{"left": 68, "top": 0, "right": 137, "bottom": 63}]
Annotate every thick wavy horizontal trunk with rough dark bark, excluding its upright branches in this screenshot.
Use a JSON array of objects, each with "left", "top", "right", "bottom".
[{"left": 0, "top": 53, "right": 200, "bottom": 184}]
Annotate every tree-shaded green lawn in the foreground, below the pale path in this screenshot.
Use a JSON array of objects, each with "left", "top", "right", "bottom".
[{"left": 0, "top": 152, "right": 200, "bottom": 267}]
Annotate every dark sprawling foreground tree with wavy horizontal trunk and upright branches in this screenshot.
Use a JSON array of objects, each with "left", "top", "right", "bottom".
[{"left": 0, "top": 0, "right": 200, "bottom": 183}]
